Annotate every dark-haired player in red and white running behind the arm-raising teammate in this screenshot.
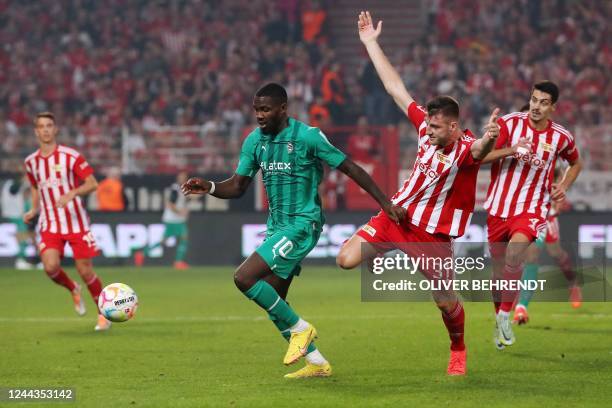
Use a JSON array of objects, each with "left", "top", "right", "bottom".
[{"left": 484, "top": 81, "right": 582, "bottom": 350}]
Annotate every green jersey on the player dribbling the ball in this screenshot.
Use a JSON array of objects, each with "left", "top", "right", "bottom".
[{"left": 236, "top": 118, "right": 346, "bottom": 229}]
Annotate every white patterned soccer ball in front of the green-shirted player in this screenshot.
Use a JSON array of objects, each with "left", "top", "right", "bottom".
[{"left": 98, "top": 283, "right": 138, "bottom": 322}]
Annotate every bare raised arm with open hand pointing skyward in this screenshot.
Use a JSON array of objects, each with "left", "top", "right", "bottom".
[{"left": 357, "top": 11, "right": 414, "bottom": 113}]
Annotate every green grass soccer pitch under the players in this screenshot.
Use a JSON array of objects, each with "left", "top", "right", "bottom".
[{"left": 0, "top": 266, "right": 612, "bottom": 407}]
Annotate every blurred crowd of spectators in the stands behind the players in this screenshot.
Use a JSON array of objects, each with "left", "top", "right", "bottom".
[{"left": 0, "top": 0, "right": 612, "bottom": 173}]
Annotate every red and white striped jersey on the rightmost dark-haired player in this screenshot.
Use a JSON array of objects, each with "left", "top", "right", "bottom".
[{"left": 484, "top": 112, "right": 578, "bottom": 219}]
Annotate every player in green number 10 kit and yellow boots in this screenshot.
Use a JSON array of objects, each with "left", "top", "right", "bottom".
[{"left": 182, "top": 83, "right": 405, "bottom": 378}]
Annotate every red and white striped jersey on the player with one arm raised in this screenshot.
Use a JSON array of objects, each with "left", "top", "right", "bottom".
[{"left": 391, "top": 102, "right": 480, "bottom": 237}]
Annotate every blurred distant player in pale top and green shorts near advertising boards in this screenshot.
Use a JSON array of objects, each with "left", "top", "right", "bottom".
[{"left": 134, "top": 171, "right": 189, "bottom": 270}]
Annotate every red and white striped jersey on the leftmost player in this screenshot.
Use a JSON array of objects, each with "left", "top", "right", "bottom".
[{"left": 25, "top": 145, "right": 93, "bottom": 235}]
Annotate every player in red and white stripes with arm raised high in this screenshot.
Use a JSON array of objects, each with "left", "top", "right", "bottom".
[{"left": 337, "top": 11, "right": 499, "bottom": 375}]
